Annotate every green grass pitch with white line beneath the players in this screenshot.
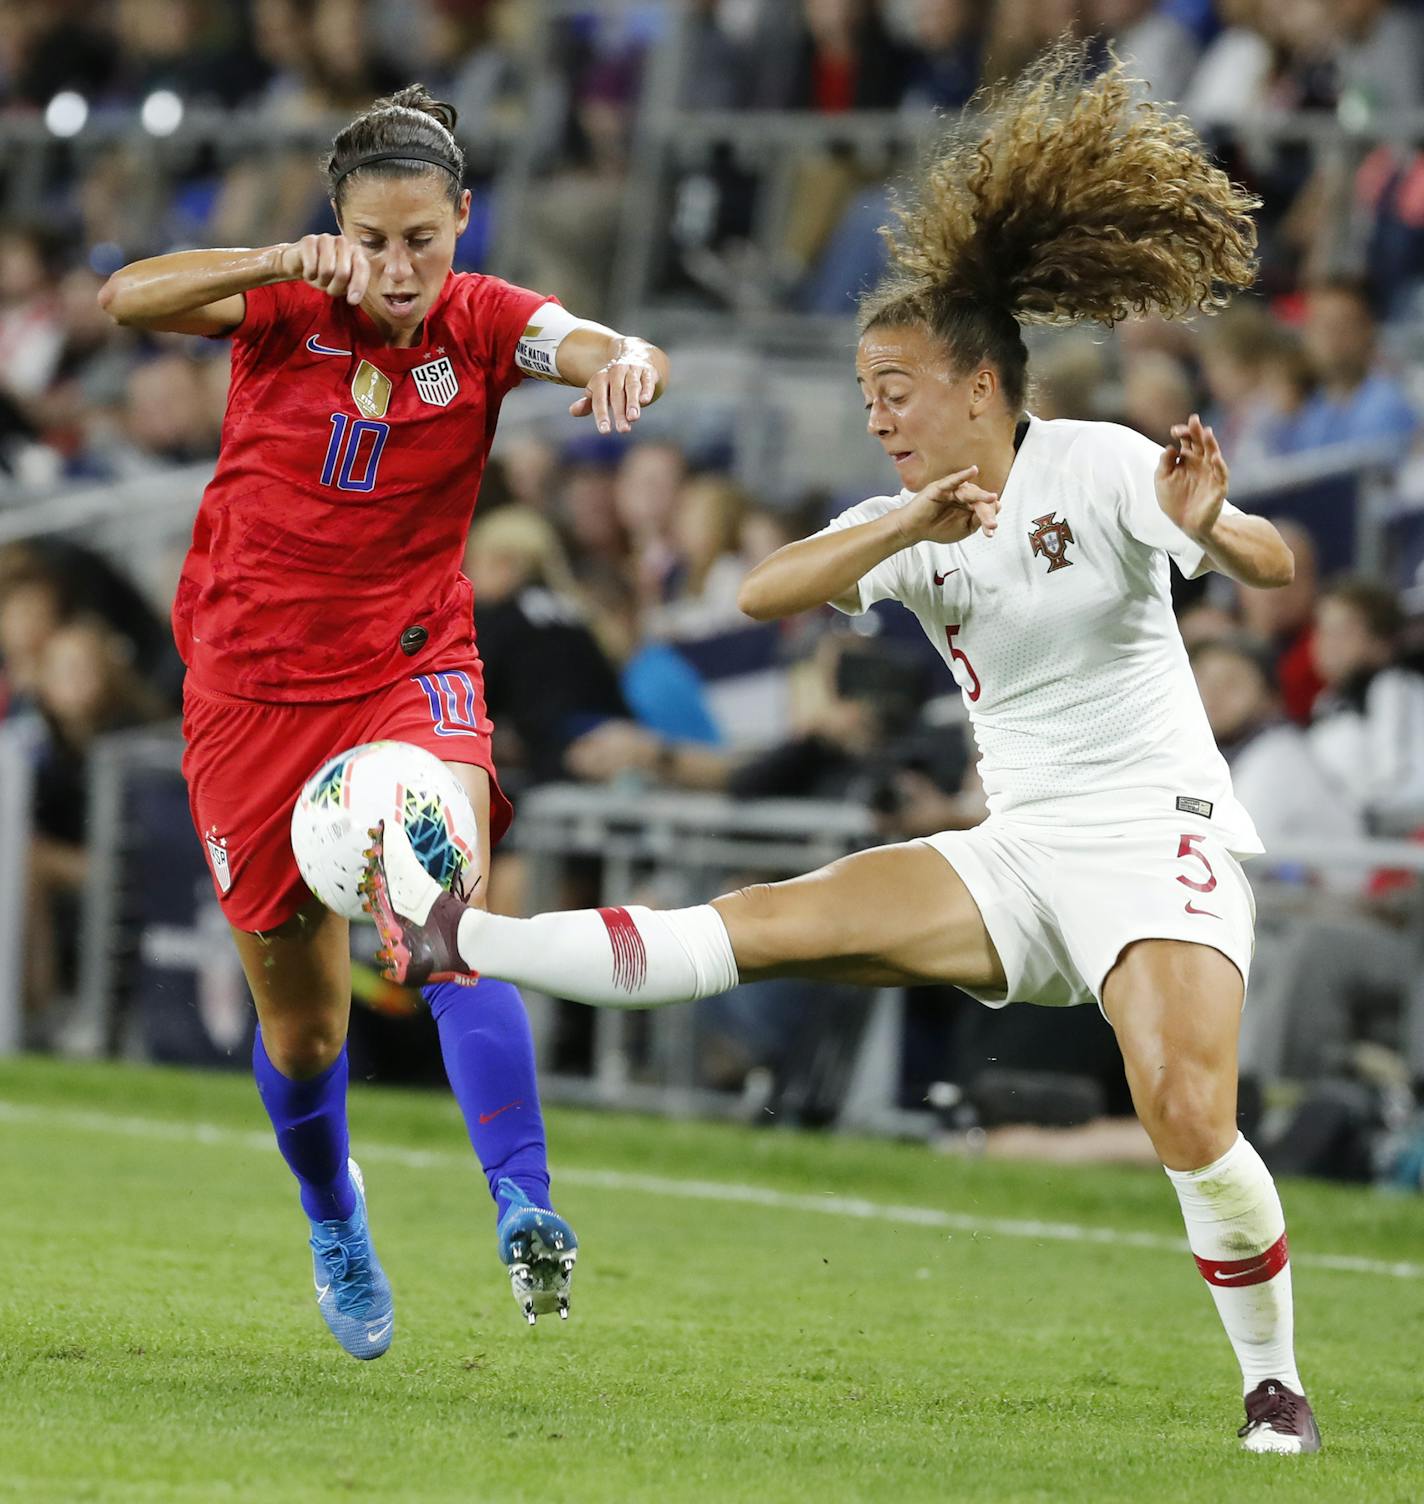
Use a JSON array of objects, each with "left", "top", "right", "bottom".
[{"left": 0, "top": 1062, "right": 1424, "bottom": 1504}]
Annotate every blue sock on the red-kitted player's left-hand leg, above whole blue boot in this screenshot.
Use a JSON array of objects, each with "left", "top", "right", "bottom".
[{"left": 253, "top": 1029, "right": 356, "bottom": 1221}]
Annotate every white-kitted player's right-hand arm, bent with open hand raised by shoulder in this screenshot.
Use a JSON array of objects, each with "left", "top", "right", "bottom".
[{"left": 1155, "top": 414, "right": 1295, "bottom": 590}]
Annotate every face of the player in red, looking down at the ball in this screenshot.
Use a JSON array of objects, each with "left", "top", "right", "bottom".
[{"left": 338, "top": 171, "right": 469, "bottom": 343}]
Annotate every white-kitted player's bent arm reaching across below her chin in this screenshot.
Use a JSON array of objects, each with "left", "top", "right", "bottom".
[{"left": 737, "top": 465, "right": 998, "bottom": 621}]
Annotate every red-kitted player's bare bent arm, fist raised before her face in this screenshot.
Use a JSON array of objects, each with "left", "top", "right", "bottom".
[{"left": 99, "top": 235, "right": 371, "bottom": 334}]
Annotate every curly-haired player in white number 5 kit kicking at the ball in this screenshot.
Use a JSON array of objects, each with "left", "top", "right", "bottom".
[{"left": 368, "top": 48, "right": 1320, "bottom": 1451}]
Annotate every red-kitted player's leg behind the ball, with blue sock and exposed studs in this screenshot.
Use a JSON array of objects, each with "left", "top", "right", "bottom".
[{"left": 421, "top": 763, "right": 579, "bottom": 1325}]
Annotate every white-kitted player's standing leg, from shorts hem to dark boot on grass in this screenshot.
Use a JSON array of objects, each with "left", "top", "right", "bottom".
[{"left": 1102, "top": 940, "right": 1320, "bottom": 1453}]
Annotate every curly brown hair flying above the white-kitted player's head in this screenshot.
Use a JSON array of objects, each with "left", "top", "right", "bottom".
[{"left": 860, "top": 41, "right": 1260, "bottom": 409}]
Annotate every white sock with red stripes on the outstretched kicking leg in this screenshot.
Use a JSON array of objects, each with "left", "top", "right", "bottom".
[{"left": 459, "top": 904, "right": 737, "bottom": 1008}]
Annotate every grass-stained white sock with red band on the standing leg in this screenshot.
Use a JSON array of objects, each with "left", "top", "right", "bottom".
[{"left": 1167, "top": 1134, "right": 1305, "bottom": 1394}]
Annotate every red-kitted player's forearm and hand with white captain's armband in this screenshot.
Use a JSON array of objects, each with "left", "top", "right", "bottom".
[{"left": 514, "top": 302, "right": 668, "bottom": 433}]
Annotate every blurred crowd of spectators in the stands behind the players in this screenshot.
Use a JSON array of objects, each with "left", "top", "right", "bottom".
[{"left": 0, "top": 0, "right": 1424, "bottom": 1173}]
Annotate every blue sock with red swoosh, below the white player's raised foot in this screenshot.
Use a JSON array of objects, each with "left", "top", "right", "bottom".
[{"left": 421, "top": 976, "right": 549, "bottom": 1217}]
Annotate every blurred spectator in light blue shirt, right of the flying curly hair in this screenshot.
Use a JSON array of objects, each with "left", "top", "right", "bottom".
[{"left": 1295, "top": 280, "right": 1419, "bottom": 457}]
